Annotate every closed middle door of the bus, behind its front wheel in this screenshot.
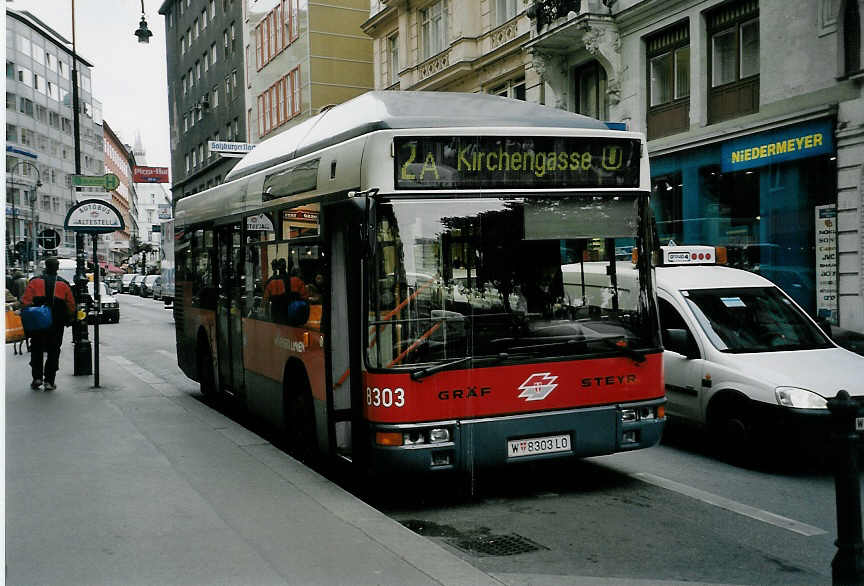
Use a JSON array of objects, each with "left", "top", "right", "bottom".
[{"left": 216, "top": 224, "right": 245, "bottom": 395}]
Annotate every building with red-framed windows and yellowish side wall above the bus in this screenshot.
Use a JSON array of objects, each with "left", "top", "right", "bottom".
[{"left": 244, "top": 0, "right": 374, "bottom": 143}]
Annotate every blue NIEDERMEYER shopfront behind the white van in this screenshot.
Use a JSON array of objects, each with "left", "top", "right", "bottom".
[{"left": 651, "top": 117, "right": 838, "bottom": 324}]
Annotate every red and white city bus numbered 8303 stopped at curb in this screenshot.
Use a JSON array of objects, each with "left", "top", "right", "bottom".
[{"left": 174, "top": 92, "right": 665, "bottom": 473}]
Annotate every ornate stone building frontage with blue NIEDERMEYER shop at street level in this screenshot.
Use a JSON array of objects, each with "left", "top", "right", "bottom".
[{"left": 364, "top": 0, "right": 864, "bottom": 331}]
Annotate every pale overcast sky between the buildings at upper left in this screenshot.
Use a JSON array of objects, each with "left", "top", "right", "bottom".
[{"left": 12, "top": 0, "right": 171, "bottom": 168}]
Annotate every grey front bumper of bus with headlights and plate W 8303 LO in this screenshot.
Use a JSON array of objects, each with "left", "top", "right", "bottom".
[{"left": 370, "top": 399, "right": 666, "bottom": 474}]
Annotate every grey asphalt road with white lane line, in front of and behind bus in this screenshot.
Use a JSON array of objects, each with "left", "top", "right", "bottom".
[{"left": 111, "top": 295, "right": 848, "bottom": 584}]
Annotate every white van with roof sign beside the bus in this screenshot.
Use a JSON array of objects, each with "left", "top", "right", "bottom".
[{"left": 655, "top": 246, "right": 864, "bottom": 455}]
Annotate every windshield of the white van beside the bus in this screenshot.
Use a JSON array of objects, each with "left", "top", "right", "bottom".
[{"left": 681, "top": 287, "right": 834, "bottom": 353}]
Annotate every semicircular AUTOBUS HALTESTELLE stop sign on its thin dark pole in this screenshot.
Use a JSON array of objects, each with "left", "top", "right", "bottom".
[{"left": 63, "top": 199, "right": 126, "bottom": 388}]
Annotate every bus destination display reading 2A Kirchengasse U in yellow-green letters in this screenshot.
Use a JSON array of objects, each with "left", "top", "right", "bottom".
[{"left": 394, "top": 136, "right": 640, "bottom": 189}]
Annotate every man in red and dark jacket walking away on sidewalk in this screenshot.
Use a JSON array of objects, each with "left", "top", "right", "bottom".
[{"left": 21, "top": 258, "right": 75, "bottom": 391}]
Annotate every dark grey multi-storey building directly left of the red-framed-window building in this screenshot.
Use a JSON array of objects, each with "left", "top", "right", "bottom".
[{"left": 159, "top": 0, "right": 248, "bottom": 201}]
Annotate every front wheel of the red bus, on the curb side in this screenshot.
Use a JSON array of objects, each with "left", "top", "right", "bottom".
[{"left": 282, "top": 366, "right": 318, "bottom": 465}]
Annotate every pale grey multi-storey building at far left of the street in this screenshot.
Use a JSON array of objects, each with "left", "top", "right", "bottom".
[{"left": 6, "top": 8, "right": 105, "bottom": 265}]
